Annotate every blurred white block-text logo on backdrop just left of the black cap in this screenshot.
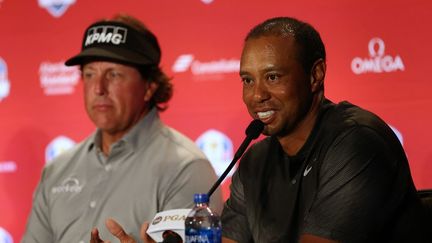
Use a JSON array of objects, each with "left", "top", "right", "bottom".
[{"left": 39, "top": 61, "right": 80, "bottom": 95}]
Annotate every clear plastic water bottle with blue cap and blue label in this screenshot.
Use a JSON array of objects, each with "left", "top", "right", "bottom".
[{"left": 185, "top": 194, "right": 222, "bottom": 243}]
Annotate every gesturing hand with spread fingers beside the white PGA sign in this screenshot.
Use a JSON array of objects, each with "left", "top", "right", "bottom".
[{"left": 90, "top": 219, "right": 155, "bottom": 243}]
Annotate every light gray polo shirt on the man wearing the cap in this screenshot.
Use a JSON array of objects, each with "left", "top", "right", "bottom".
[{"left": 22, "top": 109, "right": 222, "bottom": 243}]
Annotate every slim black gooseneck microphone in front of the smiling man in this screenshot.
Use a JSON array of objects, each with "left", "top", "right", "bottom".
[{"left": 207, "top": 119, "right": 264, "bottom": 198}]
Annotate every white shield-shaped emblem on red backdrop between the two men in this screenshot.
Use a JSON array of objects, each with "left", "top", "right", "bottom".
[{"left": 195, "top": 129, "right": 233, "bottom": 176}]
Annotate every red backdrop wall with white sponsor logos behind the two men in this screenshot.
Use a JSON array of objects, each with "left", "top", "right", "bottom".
[{"left": 0, "top": 0, "right": 432, "bottom": 242}]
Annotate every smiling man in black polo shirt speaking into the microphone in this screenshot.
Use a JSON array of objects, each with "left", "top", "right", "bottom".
[{"left": 222, "top": 17, "right": 432, "bottom": 243}]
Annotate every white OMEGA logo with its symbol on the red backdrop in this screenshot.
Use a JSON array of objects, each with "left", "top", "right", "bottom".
[{"left": 351, "top": 38, "right": 405, "bottom": 74}]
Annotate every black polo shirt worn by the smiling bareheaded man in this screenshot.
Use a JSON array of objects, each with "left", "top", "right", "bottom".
[{"left": 222, "top": 101, "right": 431, "bottom": 243}]
